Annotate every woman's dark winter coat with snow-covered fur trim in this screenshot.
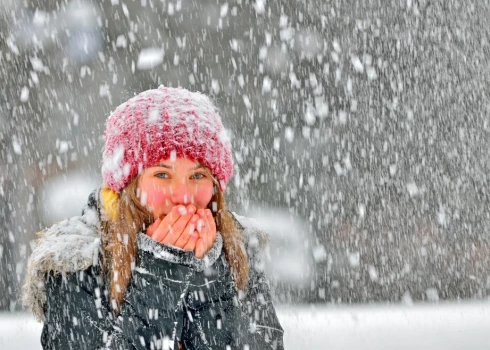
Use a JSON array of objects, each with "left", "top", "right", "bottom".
[{"left": 24, "top": 191, "right": 283, "bottom": 350}]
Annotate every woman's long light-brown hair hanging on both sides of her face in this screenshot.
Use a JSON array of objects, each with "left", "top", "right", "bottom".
[{"left": 101, "top": 176, "right": 249, "bottom": 313}]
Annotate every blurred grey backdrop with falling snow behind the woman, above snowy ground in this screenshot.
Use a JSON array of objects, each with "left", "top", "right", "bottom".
[{"left": 0, "top": 0, "right": 490, "bottom": 310}]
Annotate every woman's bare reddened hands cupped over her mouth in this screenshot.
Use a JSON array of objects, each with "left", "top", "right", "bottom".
[{"left": 146, "top": 205, "right": 216, "bottom": 259}]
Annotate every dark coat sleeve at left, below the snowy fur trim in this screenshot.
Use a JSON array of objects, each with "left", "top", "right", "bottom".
[{"left": 41, "top": 268, "right": 131, "bottom": 350}]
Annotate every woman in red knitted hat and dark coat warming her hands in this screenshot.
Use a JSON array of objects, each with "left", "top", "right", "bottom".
[{"left": 24, "top": 87, "right": 283, "bottom": 349}]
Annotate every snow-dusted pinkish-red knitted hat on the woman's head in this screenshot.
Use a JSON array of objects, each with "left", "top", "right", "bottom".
[{"left": 102, "top": 86, "right": 233, "bottom": 192}]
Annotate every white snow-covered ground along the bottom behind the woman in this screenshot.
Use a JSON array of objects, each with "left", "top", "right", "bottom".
[{"left": 0, "top": 302, "right": 490, "bottom": 350}]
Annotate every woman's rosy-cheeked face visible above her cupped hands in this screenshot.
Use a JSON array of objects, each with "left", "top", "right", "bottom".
[{"left": 137, "top": 158, "right": 214, "bottom": 219}]
